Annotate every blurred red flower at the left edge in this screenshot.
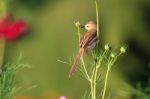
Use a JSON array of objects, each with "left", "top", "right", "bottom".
[{"left": 0, "top": 15, "right": 27, "bottom": 41}]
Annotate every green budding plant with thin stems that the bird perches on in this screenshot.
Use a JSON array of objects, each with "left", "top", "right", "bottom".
[{"left": 75, "top": 0, "right": 126, "bottom": 99}]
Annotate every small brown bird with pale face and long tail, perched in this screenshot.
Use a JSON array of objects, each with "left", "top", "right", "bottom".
[{"left": 69, "top": 21, "right": 97, "bottom": 77}]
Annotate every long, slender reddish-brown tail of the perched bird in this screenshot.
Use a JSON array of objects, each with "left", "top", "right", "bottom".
[{"left": 69, "top": 48, "right": 85, "bottom": 77}]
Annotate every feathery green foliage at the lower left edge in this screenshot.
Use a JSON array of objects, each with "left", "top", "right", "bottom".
[{"left": 0, "top": 57, "right": 30, "bottom": 99}]
